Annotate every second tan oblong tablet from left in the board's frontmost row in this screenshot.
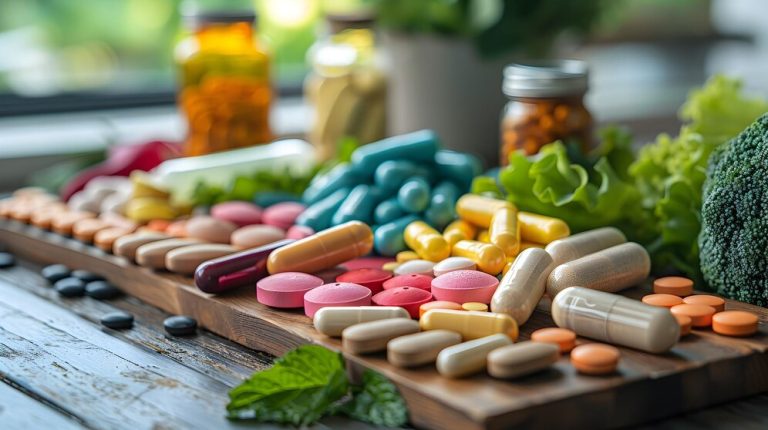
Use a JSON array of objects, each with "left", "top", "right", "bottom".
[{"left": 387, "top": 330, "right": 461, "bottom": 367}]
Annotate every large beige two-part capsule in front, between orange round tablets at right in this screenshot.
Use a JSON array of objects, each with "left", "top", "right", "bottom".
[{"left": 552, "top": 287, "right": 680, "bottom": 354}]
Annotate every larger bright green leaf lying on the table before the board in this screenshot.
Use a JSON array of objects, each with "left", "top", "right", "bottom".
[{"left": 227, "top": 345, "right": 349, "bottom": 426}]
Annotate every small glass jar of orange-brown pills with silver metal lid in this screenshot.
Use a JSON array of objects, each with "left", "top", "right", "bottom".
[{"left": 500, "top": 60, "right": 592, "bottom": 166}]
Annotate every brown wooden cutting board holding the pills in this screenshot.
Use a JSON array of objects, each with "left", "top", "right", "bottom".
[{"left": 0, "top": 220, "right": 768, "bottom": 430}]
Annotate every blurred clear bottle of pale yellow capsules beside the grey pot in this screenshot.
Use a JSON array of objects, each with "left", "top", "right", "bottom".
[{"left": 304, "top": 12, "right": 387, "bottom": 159}]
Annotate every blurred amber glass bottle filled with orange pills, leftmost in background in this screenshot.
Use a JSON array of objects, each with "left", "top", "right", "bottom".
[{"left": 176, "top": 11, "right": 272, "bottom": 155}]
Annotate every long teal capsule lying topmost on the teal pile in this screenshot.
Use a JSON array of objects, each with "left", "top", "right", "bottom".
[{"left": 352, "top": 130, "right": 440, "bottom": 172}]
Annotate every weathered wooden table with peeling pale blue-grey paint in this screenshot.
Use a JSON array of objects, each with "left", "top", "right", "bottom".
[{"left": 0, "top": 255, "right": 768, "bottom": 430}]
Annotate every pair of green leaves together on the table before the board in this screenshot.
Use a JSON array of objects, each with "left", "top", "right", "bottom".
[{"left": 227, "top": 345, "right": 408, "bottom": 427}]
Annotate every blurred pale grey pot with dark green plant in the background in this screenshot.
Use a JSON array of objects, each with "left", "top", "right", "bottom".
[{"left": 377, "top": 0, "right": 604, "bottom": 164}]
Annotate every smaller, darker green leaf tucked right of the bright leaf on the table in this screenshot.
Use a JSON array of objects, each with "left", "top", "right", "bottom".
[{"left": 338, "top": 369, "right": 408, "bottom": 427}]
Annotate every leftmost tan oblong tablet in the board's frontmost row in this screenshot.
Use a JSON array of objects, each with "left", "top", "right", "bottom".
[{"left": 341, "top": 318, "right": 419, "bottom": 354}]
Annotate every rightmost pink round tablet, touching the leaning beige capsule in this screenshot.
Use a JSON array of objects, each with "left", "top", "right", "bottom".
[{"left": 432, "top": 270, "right": 499, "bottom": 304}]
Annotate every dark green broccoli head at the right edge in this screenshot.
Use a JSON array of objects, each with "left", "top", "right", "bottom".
[{"left": 699, "top": 114, "right": 768, "bottom": 306}]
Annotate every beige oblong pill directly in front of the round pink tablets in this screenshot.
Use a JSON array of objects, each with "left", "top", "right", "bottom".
[{"left": 312, "top": 306, "right": 411, "bottom": 337}]
